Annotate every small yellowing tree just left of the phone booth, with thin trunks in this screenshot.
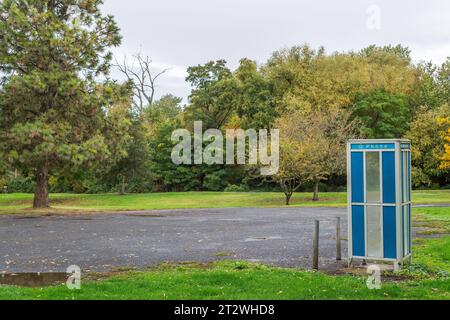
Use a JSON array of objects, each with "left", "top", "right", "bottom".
[{"left": 275, "top": 108, "right": 356, "bottom": 204}]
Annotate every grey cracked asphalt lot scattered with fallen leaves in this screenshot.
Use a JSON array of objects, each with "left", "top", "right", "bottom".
[{"left": 0, "top": 208, "right": 347, "bottom": 273}]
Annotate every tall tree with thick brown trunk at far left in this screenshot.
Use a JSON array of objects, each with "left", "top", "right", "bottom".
[{"left": 0, "top": 0, "right": 123, "bottom": 208}]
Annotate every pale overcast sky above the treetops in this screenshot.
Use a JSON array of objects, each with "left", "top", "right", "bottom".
[{"left": 103, "top": 0, "right": 450, "bottom": 101}]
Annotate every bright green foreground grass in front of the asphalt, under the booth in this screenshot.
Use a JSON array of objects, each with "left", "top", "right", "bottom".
[{"left": 0, "top": 208, "right": 450, "bottom": 300}]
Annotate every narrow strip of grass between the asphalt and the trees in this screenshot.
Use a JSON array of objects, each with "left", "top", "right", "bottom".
[{"left": 0, "top": 190, "right": 450, "bottom": 214}]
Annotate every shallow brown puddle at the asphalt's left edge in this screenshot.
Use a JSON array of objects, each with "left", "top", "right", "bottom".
[{"left": 0, "top": 272, "right": 68, "bottom": 287}]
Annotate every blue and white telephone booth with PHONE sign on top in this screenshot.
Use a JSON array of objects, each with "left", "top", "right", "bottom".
[{"left": 347, "top": 139, "right": 411, "bottom": 266}]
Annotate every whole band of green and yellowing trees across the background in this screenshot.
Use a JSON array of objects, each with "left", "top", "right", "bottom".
[{"left": 0, "top": 0, "right": 450, "bottom": 208}]
